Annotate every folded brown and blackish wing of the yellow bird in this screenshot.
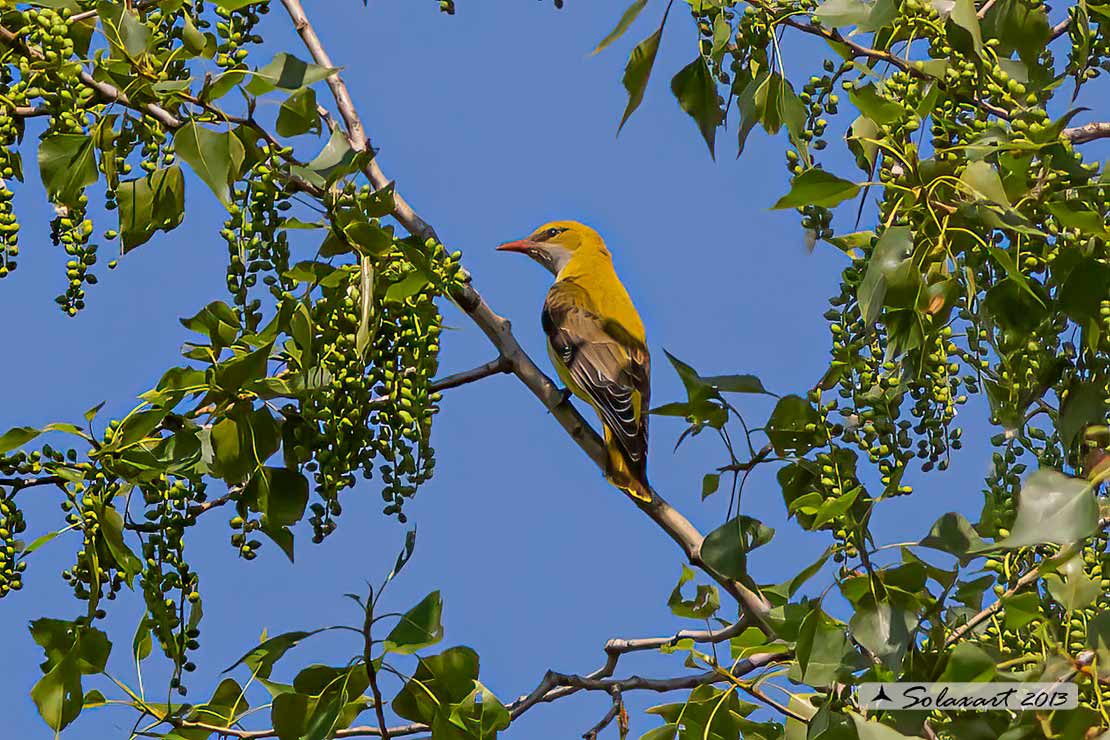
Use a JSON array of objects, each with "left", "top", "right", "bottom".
[{"left": 543, "top": 281, "right": 650, "bottom": 475}]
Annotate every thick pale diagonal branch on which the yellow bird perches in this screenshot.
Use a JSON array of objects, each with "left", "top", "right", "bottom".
[{"left": 275, "top": 0, "right": 774, "bottom": 633}]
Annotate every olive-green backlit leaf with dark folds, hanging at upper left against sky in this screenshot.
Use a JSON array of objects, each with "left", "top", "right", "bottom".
[{"left": 117, "top": 164, "right": 185, "bottom": 254}]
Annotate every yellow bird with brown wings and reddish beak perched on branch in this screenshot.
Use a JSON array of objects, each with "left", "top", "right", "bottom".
[{"left": 497, "top": 221, "right": 652, "bottom": 503}]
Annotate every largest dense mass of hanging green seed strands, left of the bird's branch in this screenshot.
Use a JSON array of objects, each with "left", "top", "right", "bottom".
[{"left": 285, "top": 240, "right": 463, "bottom": 532}]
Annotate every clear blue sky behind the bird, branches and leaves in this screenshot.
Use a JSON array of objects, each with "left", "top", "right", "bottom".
[{"left": 0, "top": 0, "right": 1016, "bottom": 740}]
